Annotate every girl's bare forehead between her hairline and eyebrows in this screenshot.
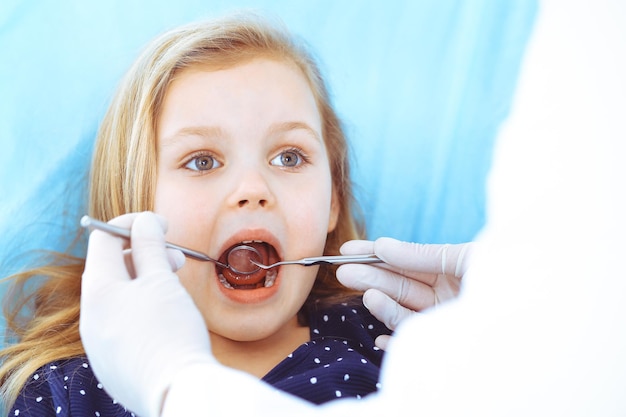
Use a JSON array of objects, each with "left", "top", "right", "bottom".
[{"left": 157, "top": 57, "right": 322, "bottom": 142}]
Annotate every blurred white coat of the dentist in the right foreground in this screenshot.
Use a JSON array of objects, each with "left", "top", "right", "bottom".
[{"left": 382, "top": 0, "right": 626, "bottom": 417}]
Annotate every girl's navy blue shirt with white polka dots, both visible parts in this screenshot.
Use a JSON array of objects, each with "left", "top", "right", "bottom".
[{"left": 9, "top": 304, "right": 391, "bottom": 417}]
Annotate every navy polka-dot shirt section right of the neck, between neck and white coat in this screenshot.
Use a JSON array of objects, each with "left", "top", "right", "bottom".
[{"left": 263, "top": 302, "right": 391, "bottom": 404}]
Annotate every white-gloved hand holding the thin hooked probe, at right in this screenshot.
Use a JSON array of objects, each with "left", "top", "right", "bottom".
[{"left": 337, "top": 238, "right": 473, "bottom": 349}]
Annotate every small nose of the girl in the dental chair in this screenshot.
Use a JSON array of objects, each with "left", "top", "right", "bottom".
[{"left": 228, "top": 169, "right": 275, "bottom": 209}]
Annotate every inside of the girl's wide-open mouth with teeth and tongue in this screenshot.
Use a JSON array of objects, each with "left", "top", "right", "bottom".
[{"left": 217, "top": 240, "right": 280, "bottom": 290}]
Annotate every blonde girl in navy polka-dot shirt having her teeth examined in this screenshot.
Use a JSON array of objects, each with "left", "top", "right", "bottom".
[{"left": 0, "top": 11, "right": 390, "bottom": 416}]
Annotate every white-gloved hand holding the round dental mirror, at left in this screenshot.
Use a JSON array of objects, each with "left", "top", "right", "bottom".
[{"left": 80, "top": 212, "right": 214, "bottom": 417}]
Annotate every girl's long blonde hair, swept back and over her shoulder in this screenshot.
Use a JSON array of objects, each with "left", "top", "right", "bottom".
[{"left": 0, "top": 14, "right": 363, "bottom": 405}]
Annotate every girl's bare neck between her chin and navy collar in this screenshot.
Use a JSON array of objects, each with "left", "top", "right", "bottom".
[{"left": 209, "top": 320, "right": 311, "bottom": 378}]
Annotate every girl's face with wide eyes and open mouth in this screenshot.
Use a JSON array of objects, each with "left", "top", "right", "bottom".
[{"left": 154, "top": 59, "right": 339, "bottom": 341}]
